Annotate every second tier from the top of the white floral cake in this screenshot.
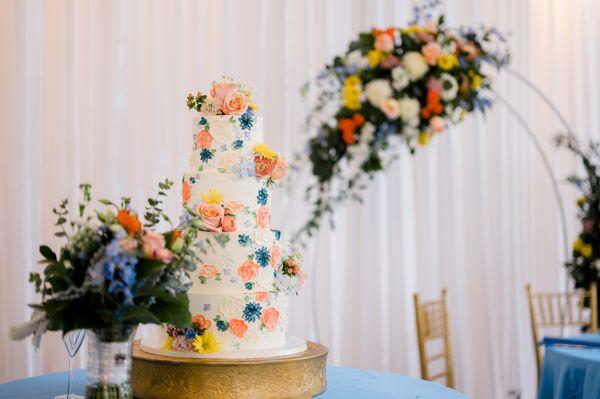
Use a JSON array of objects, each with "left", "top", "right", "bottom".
[{"left": 183, "top": 172, "right": 271, "bottom": 231}]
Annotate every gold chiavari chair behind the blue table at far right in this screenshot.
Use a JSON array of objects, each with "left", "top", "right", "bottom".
[{"left": 525, "top": 282, "right": 598, "bottom": 380}]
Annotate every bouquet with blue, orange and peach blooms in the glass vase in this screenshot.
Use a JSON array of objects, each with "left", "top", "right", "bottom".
[{"left": 11, "top": 180, "right": 204, "bottom": 346}]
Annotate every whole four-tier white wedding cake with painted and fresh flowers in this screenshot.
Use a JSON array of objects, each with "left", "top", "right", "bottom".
[{"left": 144, "top": 81, "right": 306, "bottom": 358}]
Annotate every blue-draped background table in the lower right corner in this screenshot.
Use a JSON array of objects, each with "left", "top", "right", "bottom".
[{"left": 538, "top": 334, "right": 600, "bottom": 399}]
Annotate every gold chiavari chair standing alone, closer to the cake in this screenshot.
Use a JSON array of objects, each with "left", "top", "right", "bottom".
[{"left": 414, "top": 289, "right": 454, "bottom": 388}]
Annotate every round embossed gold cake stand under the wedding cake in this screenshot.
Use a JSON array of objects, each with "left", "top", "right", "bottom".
[{"left": 131, "top": 340, "right": 328, "bottom": 399}]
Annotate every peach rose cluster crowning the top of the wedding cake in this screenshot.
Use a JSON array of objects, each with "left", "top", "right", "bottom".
[{"left": 187, "top": 79, "right": 258, "bottom": 115}]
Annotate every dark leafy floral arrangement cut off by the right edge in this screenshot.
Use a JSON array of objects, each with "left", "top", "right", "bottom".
[{"left": 555, "top": 134, "right": 600, "bottom": 304}]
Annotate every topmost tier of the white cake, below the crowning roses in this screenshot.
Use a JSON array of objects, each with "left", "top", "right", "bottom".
[{"left": 189, "top": 113, "right": 263, "bottom": 174}]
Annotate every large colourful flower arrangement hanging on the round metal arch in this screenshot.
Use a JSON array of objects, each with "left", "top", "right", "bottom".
[{"left": 296, "top": 0, "right": 509, "bottom": 238}]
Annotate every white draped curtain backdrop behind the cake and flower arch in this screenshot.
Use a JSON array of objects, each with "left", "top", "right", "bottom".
[{"left": 0, "top": 0, "right": 600, "bottom": 398}]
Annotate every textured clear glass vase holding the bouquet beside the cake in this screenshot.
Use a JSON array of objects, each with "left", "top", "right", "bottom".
[{"left": 85, "top": 327, "right": 134, "bottom": 399}]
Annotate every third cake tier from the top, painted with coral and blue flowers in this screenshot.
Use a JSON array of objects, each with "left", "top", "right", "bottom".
[{"left": 190, "top": 230, "right": 281, "bottom": 294}]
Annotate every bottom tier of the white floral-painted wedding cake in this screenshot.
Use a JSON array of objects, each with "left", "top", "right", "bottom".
[{"left": 188, "top": 291, "right": 288, "bottom": 353}]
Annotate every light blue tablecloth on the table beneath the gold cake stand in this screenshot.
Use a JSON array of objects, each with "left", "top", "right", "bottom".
[{"left": 0, "top": 367, "right": 466, "bottom": 399}]
